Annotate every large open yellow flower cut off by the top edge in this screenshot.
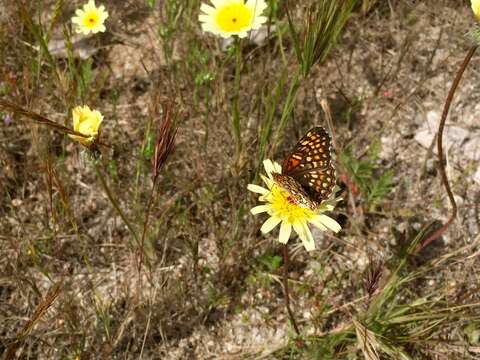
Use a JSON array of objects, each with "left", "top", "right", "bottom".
[{"left": 198, "top": 0, "right": 268, "bottom": 38}]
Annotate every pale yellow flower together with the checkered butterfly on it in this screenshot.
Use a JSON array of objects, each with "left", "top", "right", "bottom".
[{"left": 248, "top": 127, "right": 341, "bottom": 251}]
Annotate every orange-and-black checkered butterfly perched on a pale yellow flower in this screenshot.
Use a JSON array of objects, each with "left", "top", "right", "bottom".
[{"left": 272, "top": 126, "right": 335, "bottom": 210}]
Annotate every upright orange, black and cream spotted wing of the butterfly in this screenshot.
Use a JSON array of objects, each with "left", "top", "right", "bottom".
[{"left": 282, "top": 127, "right": 335, "bottom": 202}]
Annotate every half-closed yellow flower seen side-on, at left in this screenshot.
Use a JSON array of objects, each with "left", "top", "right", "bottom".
[{"left": 68, "top": 105, "right": 103, "bottom": 146}]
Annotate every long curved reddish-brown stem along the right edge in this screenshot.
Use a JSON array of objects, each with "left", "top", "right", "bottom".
[{"left": 415, "top": 46, "right": 478, "bottom": 254}]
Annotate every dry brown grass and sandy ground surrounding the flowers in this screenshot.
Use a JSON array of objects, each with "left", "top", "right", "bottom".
[{"left": 0, "top": 0, "right": 480, "bottom": 359}]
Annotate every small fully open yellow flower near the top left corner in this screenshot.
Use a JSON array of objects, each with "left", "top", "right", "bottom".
[{"left": 72, "top": 0, "right": 108, "bottom": 35}]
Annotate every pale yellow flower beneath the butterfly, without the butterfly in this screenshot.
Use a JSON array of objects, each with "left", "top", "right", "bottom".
[{"left": 247, "top": 159, "right": 341, "bottom": 251}]
